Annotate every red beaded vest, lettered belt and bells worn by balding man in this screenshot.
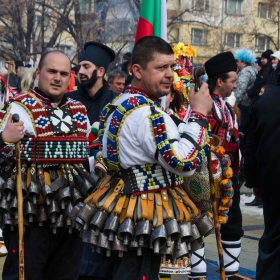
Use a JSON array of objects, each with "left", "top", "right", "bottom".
[{"left": 0, "top": 93, "right": 94, "bottom": 233}]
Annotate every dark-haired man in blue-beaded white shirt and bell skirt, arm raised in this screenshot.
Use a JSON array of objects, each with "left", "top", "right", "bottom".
[{"left": 79, "top": 36, "right": 212, "bottom": 280}]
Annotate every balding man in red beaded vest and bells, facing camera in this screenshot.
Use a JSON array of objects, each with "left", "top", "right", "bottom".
[{"left": 0, "top": 51, "right": 93, "bottom": 280}]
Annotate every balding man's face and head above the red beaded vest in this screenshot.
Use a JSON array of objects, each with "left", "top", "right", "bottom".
[{"left": 36, "top": 52, "right": 71, "bottom": 102}]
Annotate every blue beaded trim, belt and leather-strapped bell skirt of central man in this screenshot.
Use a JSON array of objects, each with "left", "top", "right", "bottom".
[{"left": 80, "top": 91, "right": 212, "bottom": 274}]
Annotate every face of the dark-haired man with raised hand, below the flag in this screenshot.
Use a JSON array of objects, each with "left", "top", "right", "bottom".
[{"left": 137, "top": 53, "right": 175, "bottom": 98}]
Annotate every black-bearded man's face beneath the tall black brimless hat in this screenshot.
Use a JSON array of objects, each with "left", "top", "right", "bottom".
[{"left": 79, "top": 60, "right": 98, "bottom": 89}]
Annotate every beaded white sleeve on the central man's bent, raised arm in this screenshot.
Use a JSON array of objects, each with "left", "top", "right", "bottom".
[{"left": 150, "top": 108, "right": 211, "bottom": 172}]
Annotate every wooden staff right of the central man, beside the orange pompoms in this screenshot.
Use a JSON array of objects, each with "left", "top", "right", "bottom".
[{"left": 207, "top": 151, "right": 226, "bottom": 280}]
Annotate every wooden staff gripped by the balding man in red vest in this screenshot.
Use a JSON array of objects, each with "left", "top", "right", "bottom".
[{"left": 13, "top": 114, "right": 24, "bottom": 280}]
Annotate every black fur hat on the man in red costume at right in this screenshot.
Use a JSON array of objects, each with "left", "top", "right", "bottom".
[{"left": 205, "top": 52, "right": 237, "bottom": 78}]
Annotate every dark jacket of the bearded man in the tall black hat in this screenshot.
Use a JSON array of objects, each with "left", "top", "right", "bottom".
[{"left": 67, "top": 81, "right": 116, "bottom": 124}]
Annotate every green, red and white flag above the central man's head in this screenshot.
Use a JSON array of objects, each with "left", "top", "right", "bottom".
[{"left": 134, "top": 0, "right": 167, "bottom": 44}]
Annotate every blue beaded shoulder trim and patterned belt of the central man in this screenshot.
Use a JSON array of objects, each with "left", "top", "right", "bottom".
[{"left": 99, "top": 92, "right": 208, "bottom": 193}]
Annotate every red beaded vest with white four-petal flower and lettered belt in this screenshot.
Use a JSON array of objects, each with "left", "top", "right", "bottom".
[{"left": 0, "top": 93, "right": 88, "bottom": 163}]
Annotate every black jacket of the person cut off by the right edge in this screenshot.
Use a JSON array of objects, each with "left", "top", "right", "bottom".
[{"left": 243, "top": 86, "right": 280, "bottom": 209}]
